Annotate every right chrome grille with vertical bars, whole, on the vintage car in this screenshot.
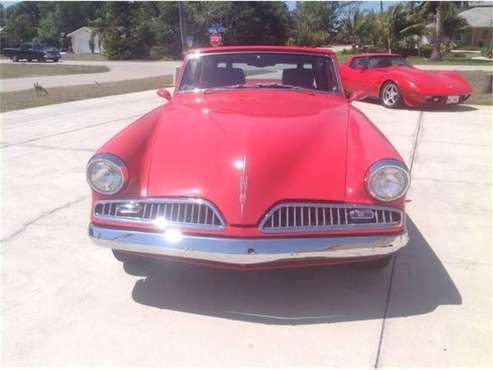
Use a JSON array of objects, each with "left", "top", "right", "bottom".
[{"left": 260, "top": 202, "right": 403, "bottom": 232}]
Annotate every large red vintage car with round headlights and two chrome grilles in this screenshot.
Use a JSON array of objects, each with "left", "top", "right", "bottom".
[{"left": 87, "top": 46, "right": 410, "bottom": 269}]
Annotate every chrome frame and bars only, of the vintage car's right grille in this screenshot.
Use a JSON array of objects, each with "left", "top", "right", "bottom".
[{"left": 259, "top": 202, "right": 404, "bottom": 233}]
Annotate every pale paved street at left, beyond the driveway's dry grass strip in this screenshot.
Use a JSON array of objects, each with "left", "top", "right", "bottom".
[{"left": 0, "top": 59, "right": 181, "bottom": 92}]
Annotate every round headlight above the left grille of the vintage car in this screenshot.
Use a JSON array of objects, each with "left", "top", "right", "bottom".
[{"left": 86, "top": 153, "right": 127, "bottom": 195}]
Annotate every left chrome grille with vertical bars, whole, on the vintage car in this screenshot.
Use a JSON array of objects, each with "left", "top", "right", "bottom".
[{"left": 94, "top": 198, "right": 225, "bottom": 230}]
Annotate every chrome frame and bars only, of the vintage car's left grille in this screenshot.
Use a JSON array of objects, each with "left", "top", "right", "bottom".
[{"left": 92, "top": 198, "right": 226, "bottom": 230}]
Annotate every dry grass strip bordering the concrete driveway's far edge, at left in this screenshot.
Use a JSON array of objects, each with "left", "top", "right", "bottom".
[{"left": 0, "top": 75, "right": 173, "bottom": 112}]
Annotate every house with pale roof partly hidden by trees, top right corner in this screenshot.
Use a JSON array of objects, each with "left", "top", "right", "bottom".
[{"left": 454, "top": 1, "right": 493, "bottom": 47}]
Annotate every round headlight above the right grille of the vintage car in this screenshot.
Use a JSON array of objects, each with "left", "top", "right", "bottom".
[{"left": 366, "top": 159, "right": 410, "bottom": 202}]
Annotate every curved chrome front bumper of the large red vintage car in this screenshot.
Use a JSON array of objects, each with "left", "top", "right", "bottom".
[{"left": 89, "top": 224, "right": 409, "bottom": 265}]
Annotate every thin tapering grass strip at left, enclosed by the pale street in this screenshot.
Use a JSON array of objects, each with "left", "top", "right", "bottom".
[{"left": 0, "top": 63, "right": 110, "bottom": 79}]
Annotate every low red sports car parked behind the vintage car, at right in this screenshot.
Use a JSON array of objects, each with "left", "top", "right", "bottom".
[{"left": 340, "top": 53, "right": 472, "bottom": 108}]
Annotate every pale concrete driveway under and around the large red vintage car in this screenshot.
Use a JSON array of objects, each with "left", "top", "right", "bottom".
[{"left": 0, "top": 91, "right": 493, "bottom": 367}]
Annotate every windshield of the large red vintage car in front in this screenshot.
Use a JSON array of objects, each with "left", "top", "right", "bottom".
[{"left": 179, "top": 52, "right": 341, "bottom": 93}]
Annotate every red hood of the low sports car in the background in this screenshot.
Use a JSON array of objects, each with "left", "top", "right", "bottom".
[{"left": 391, "top": 67, "right": 470, "bottom": 95}]
